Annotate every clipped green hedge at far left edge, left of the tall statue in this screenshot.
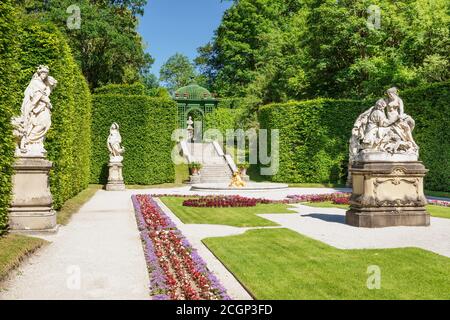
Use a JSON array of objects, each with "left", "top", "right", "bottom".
[{"left": 0, "top": 0, "right": 20, "bottom": 236}]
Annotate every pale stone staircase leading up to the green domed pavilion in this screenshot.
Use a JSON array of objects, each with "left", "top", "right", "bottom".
[{"left": 182, "top": 143, "right": 233, "bottom": 183}]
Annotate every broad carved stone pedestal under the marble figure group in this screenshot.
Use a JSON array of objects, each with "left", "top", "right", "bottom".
[{"left": 345, "top": 161, "right": 430, "bottom": 228}]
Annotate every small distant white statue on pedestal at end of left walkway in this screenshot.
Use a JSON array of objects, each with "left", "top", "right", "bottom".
[{"left": 106, "top": 122, "right": 125, "bottom": 191}]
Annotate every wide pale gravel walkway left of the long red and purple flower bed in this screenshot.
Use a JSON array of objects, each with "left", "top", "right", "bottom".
[{"left": 0, "top": 191, "right": 149, "bottom": 300}]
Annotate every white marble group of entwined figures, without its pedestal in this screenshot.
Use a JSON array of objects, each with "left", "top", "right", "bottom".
[{"left": 349, "top": 88, "right": 419, "bottom": 163}]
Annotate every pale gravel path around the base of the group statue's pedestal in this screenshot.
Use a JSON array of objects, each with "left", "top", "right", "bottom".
[{"left": 259, "top": 204, "right": 450, "bottom": 257}]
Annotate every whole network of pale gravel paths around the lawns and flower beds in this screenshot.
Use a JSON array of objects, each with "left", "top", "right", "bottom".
[{"left": 0, "top": 187, "right": 450, "bottom": 300}]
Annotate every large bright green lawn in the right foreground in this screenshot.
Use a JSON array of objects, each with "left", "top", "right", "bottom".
[{"left": 204, "top": 229, "right": 450, "bottom": 300}]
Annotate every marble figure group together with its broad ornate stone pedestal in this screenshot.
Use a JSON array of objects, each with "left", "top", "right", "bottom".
[{"left": 346, "top": 88, "right": 430, "bottom": 227}]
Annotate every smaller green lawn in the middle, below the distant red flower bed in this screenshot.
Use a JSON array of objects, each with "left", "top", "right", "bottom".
[{"left": 161, "top": 197, "right": 295, "bottom": 227}]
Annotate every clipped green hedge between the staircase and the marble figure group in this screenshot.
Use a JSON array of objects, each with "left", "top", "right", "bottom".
[{"left": 259, "top": 99, "right": 368, "bottom": 183}]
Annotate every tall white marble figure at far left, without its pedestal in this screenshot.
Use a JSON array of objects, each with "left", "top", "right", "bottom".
[{"left": 11, "top": 65, "right": 58, "bottom": 157}]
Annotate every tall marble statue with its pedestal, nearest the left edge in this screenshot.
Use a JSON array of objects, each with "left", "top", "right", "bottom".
[{"left": 9, "top": 65, "right": 58, "bottom": 233}]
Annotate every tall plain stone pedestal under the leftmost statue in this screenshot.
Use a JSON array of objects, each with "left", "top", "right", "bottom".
[{"left": 9, "top": 157, "right": 58, "bottom": 234}]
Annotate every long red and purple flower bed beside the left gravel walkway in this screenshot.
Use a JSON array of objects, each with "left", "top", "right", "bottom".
[{"left": 132, "top": 195, "right": 230, "bottom": 300}]
